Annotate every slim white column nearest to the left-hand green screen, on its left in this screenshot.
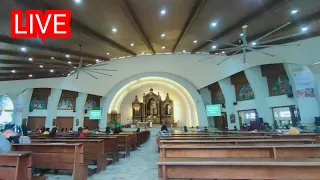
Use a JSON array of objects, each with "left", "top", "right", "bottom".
[{"left": 72, "top": 92, "right": 88, "bottom": 131}]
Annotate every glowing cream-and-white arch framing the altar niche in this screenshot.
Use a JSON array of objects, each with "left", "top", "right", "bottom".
[{"left": 100, "top": 72, "right": 208, "bottom": 127}]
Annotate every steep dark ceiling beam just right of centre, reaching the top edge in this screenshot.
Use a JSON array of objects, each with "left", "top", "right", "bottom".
[{"left": 172, "top": 0, "right": 207, "bottom": 53}]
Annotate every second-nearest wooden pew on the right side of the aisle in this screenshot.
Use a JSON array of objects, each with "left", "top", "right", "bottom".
[{"left": 160, "top": 144, "right": 320, "bottom": 158}]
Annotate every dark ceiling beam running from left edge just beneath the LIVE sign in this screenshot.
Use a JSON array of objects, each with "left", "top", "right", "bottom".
[{"left": 0, "top": 34, "right": 109, "bottom": 61}]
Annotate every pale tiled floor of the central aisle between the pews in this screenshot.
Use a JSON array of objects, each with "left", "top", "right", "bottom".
[{"left": 47, "top": 129, "right": 159, "bottom": 180}]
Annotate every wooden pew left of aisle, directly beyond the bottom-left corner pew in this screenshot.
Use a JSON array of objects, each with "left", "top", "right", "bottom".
[{"left": 11, "top": 143, "right": 88, "bottom": 180}]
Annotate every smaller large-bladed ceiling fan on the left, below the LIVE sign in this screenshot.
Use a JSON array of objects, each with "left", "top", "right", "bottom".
[{"left": 62, "top": 45, "right": 117, "bottom": 79}]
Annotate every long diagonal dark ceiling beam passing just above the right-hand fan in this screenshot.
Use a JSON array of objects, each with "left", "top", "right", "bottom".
[{"left": 191, "top": 0, "right": 291, "bottom": 53}]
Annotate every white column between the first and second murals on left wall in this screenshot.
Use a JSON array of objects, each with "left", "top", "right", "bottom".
[{"left": 45, "top": 89, "right": 62, "bottom": 129}]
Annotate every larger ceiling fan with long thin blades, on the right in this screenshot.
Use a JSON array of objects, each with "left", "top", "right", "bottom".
[{"left": 199, "top": 22, "right": 307, "bottom": 65}]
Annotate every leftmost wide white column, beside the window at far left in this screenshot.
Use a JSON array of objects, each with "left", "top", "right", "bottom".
[{"left": 10, "top": 88, "right": 33, "bottom": 125}]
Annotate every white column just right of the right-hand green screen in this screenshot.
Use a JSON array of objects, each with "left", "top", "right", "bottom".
[{"left": 219, "top": 77, "right": 240, "bottom": 130}]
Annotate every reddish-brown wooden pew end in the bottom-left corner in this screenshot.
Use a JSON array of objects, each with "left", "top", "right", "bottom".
[{"left": 0, "top": 151, "right": 32, "bottom": 180}]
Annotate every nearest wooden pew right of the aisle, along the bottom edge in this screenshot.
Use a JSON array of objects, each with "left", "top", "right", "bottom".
[{"left": 158, "top": 158, "right": 320, "bottom": 180}]
